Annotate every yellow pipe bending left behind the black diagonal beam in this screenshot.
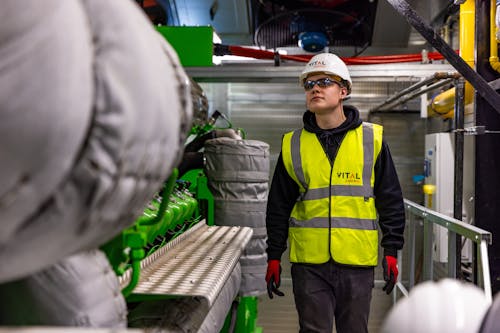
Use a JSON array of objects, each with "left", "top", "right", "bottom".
[{"left": 427, "top": 0, "right": 474, "bottom": 119}]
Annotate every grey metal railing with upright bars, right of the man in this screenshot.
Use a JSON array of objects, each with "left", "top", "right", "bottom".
[{"left": 393, "top": 199, "right": 492, "bottom": 303}]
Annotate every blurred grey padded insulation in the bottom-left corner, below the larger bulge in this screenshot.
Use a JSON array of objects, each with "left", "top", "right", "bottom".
[{"left": 0, "top": 249, "right": 127, "bottom": 331}]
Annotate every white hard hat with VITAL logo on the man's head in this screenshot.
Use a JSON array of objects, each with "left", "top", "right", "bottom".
[{"left": 299, "top": 53, "right": 352, "bottom": 94}]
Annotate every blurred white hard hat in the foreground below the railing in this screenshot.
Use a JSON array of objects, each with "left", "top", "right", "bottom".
[{"left": 381, "top": 278, "right": 490, "bottom": 333}]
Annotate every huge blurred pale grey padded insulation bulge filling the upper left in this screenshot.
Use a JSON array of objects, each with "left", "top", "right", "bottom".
[{"left": 0, "top": 0, "right": 192, "bottom": 282}]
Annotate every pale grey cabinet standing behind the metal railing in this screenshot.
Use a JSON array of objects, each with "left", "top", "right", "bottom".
[{"left": 424, "top": 133, "right": 474, "bottom": 262}]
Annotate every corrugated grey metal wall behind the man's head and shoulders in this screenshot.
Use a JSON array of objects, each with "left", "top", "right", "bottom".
[{"left": 200, "top": 79, "right": 425, "bottom": 183}]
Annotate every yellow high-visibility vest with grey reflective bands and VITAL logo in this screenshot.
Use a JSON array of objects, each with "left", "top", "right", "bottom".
[{"left": 282, "top": 123, "right": 383, "bottom": 266}]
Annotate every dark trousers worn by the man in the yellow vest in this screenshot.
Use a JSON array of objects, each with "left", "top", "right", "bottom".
[{"left": 292, "top": 261, "right": 375, "bottom": 333}]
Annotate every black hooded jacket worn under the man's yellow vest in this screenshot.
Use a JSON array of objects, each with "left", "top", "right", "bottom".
[{"left": 266, "top": 105, "right": 405, "bottom": 260}]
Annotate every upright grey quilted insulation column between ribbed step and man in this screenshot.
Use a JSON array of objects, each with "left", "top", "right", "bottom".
[{"left": 205, "top": 137, "right": 270, "bottom": 296}]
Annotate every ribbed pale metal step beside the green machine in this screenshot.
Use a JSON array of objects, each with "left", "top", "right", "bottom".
[{"left": 119, "top": 221, "right": 253, "bottom": 307}]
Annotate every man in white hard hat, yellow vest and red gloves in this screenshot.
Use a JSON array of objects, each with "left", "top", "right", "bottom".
[{"left": 266, "top": 53, "right": 405, "bottom": 333}]
